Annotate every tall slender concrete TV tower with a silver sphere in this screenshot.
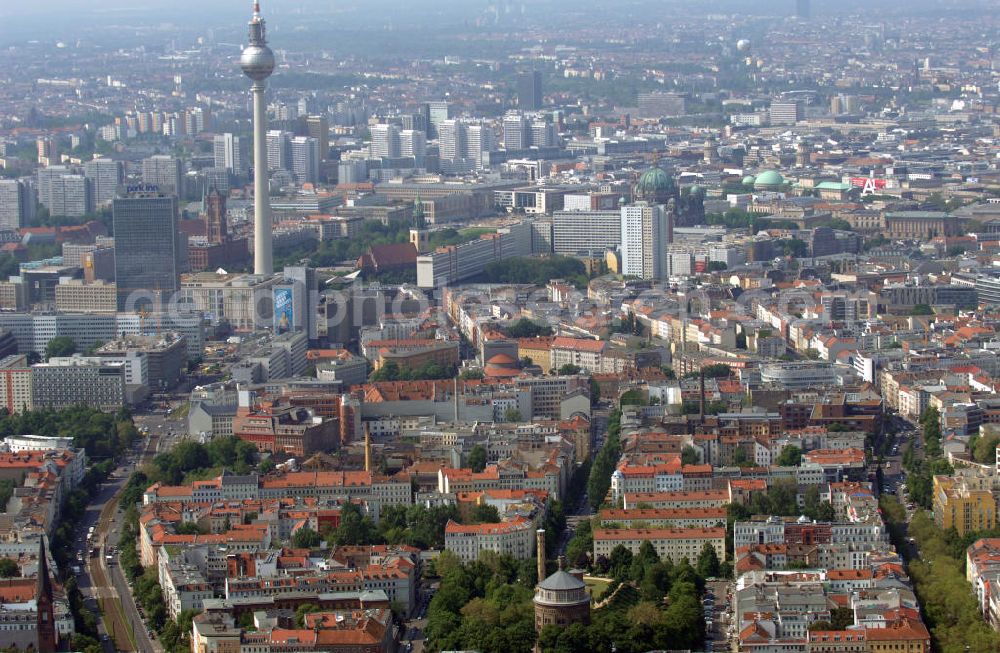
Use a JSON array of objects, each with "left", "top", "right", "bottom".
[{"left": 240, "top": 2, "right": 274, "bottom": 275}]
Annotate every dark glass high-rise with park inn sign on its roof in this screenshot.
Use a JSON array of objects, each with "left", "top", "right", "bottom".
[{"left": 112, "top": 192, "right": 186, "bottom": 311}]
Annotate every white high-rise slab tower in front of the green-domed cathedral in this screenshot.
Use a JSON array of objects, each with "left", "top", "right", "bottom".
[{"left": 621, "top": 202, "right": 671, "bottom": 279}]
